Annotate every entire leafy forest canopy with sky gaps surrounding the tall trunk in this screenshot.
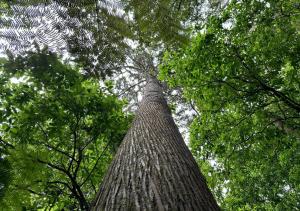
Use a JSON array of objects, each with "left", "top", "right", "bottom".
[{"left": 0, "top": 0, "right": 300, "bottom": 210}]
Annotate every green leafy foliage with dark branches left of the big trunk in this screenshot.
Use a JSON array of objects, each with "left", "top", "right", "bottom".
[{"left": 0, "top": 49, "right": 131, "bottom": 210}]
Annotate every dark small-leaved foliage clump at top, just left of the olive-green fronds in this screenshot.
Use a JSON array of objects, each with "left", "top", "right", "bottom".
[{"left": 61, "top": 0, "right": 133, "bottom": 78}]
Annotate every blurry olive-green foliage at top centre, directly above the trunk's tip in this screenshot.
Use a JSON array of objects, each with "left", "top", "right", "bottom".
[{"left": 124, "top": 0, "right": 191, "bottom": 46}]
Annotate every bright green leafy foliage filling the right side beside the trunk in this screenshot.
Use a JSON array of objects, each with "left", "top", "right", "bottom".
[{"left": 160, "top": 0, "right": 300, "bottom": 210}]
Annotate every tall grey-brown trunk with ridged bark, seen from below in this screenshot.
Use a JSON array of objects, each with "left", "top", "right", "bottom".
[{"left": 92, "top": 78, "right": 219, "bottom": 211}]
